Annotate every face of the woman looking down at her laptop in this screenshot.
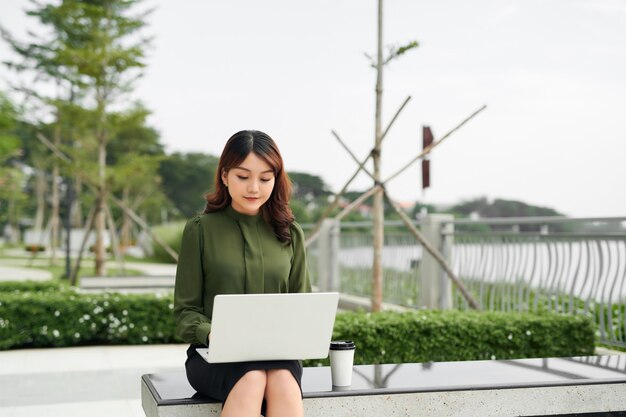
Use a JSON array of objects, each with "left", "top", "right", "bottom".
[{"left": 222, "top": 152, "right": 274, "bottom": 216}]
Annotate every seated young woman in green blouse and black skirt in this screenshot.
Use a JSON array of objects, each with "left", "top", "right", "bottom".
[{"left": 174, "top": 130, "right": 311, "bottom": 417}]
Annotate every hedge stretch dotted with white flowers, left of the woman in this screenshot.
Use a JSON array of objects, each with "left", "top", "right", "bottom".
[{"left": 0, "top": 290, "right": 177, "bottom": 349}]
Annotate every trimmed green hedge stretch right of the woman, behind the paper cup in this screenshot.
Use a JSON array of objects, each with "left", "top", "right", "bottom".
[{"left": 306, "top": 310, "right": 595, "bottom": 366}]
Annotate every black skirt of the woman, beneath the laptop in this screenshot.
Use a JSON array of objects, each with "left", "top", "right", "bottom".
[{"left": 185, "top": 345, "right": 302, "bottom": 415}]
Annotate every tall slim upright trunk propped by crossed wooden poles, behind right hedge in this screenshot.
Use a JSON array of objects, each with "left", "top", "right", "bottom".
[{"left": 372, "top": 0, "right": 385, "bottom": 311}]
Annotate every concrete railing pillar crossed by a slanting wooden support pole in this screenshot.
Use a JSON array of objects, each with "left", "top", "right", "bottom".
[{"left": 420, "top": 214, "right": 454, "bottom": 310}]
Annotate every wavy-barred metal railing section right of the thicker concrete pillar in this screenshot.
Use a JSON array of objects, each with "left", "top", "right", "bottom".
[{"left": 452, "top": 218, "right": 626, "bottom": 347}]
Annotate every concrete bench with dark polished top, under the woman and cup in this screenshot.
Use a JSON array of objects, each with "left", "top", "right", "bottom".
[{"left": 141, "top": 355, "right": 626, "bottom": 417}]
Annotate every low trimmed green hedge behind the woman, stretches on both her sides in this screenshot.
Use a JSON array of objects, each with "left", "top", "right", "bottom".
[{"left": 0, "top": 289, "right": 594, "bottom": 366}]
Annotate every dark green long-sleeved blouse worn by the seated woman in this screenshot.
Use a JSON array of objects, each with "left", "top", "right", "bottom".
[{"left": 174, "top": 206, "right": 311, "bottom": 345}]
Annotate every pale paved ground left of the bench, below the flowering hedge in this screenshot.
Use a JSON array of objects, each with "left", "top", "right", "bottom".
[{"left": 0, "top": 344, "right": 187, "bottom": 417}]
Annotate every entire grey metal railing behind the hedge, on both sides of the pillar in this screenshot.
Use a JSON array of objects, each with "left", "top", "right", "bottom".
[{"left": 305, "top": 217, "right": 626, "bottom": 347}]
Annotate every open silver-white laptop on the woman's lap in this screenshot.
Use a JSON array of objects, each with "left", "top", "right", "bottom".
[{"left": 197, "top": 292, "right": 339, "bottom": 363}]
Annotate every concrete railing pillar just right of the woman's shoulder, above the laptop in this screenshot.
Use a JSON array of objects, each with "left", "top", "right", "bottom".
[{"left": 317, "top": 219, "right": 340, "bottom": 291}]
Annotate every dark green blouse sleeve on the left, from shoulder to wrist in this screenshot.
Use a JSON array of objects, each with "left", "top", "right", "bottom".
[{"left": 174, "top": 216, "right": 211, "bottom": 345}]
